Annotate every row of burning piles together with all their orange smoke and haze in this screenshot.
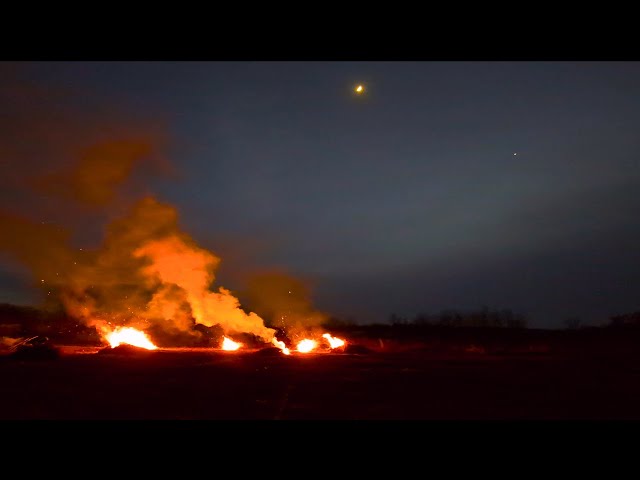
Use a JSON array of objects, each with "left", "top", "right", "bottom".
[{"left": 0, "top": 77, "right": 344, "bottom": 354}]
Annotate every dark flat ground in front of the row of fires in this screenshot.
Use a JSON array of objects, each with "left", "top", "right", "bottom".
[{"left": 0, "top": 340, "right": 640, "bottom": 420}]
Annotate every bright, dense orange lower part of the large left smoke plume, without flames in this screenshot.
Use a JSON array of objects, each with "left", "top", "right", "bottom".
[{"left": 61, "top": 197, "right": 274, "bottom": 342}]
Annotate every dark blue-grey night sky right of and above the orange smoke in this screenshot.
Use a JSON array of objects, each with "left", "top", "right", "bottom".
[{"left": 0, "top": 61, "right": 640, "bottom": 328}]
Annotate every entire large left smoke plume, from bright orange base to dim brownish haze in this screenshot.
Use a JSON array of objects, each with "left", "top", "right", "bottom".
[{"left": 0, "top": 66, "right": 275, "bottom": 342}]
